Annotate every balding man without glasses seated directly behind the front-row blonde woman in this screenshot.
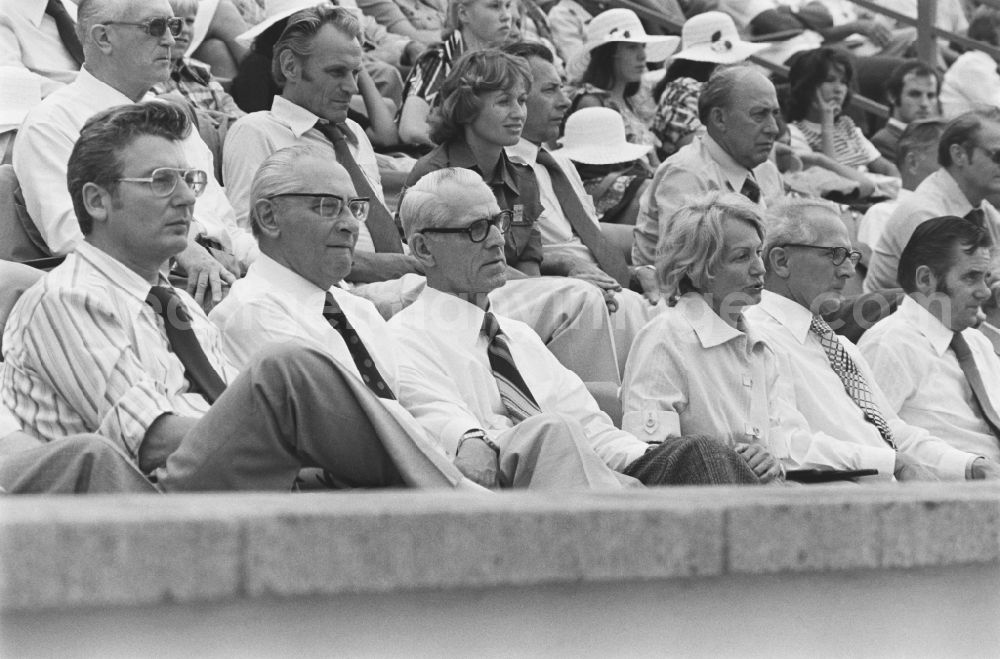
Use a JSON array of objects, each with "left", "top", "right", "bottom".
[{"left": 632, "top": 66, "right": 785, "bottom": 266}]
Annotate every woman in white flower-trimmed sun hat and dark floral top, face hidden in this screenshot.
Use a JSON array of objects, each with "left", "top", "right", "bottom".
[{"left": 652, "top": 11, "right": 771, "bottom": 157}]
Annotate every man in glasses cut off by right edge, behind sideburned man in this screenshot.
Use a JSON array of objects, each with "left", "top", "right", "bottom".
[{"left": 864, "top": 110, "right": 1000, "bottom": 293}]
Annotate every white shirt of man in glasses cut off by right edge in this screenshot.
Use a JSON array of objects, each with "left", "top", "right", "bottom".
[{"left": 864, "top": 168, "right": 1000, "bottom": 293}]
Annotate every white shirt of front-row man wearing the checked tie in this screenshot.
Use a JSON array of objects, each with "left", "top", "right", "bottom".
[{"left": 746, "top": 291, "right": 978, "bottom": 480}]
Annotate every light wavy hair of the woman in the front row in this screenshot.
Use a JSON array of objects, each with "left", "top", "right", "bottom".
[{"left": 656, "top": 191, "right": 764, "bottom": 301}]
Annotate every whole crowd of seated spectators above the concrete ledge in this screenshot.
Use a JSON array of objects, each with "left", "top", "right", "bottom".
[{"left": 0, "top": 0, "right": 1000, "bottom": 493}]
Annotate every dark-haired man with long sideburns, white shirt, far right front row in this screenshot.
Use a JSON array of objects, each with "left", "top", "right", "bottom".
[{"left": 858, "top": 217, "right": 1000, "bottom": 476}]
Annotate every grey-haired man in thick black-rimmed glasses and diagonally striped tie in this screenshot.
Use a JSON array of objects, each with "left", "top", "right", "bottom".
[{"left": 389, "top": 168, "right": 757, "bottom": 487}]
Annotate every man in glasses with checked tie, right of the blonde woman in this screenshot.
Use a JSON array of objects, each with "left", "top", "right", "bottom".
[{"left": 746, "top": 199, "right": 1000, "bottom": 480}]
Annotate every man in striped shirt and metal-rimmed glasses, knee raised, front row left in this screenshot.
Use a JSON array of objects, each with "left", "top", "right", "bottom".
[{"left": 0, "top": 104, "right": 478, "bottom": 492}]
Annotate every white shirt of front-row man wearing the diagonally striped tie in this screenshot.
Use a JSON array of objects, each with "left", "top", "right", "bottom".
[{"left": 389, "top": 286, "right": 649, "bottom": 471}]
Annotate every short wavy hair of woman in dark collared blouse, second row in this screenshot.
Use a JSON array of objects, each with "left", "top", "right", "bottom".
[{"left": 430, "top": 48, "right": 531, "bottom": 144}]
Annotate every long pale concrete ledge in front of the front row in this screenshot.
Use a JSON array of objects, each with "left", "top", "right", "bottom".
[{"left": 0, "top": 483, "right": 1000, "bottom": 613}]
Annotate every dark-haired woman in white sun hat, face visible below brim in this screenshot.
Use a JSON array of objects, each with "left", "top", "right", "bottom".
[{"left": 570, "top": 9, "right": 680, "bottom": 164}]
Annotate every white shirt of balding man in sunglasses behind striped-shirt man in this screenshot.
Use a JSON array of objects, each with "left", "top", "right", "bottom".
[{"left": 14, "top": 67, "right": 257, "bottom": 265}]
